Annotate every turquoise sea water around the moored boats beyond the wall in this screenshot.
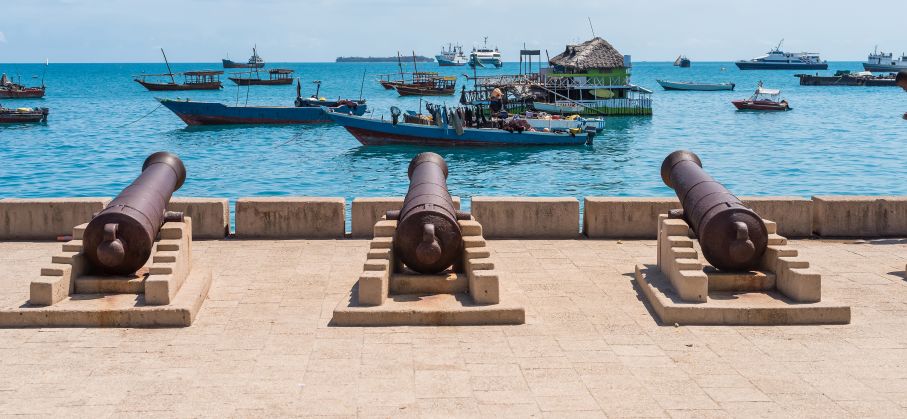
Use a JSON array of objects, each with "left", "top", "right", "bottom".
[{"left": 0, "top": 62, "right": 907, "bottom": 208}]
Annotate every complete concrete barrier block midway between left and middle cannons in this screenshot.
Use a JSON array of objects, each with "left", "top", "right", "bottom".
[{"left": 236, "top": 197, "right": 346, "bottom": 239}]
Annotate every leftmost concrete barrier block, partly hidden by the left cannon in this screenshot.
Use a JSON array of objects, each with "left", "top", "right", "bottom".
[{"left": 0, "top": 198, "right": 110, "bottom": 240}]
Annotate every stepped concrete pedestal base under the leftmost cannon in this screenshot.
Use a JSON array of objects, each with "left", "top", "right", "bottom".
[{"left": 0, "top": 217, "right": 211, "bottom": 327}]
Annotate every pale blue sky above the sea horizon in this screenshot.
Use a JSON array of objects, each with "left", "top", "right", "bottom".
[{"left": 0, "top": 0, "right": 907, "bottom": 63}]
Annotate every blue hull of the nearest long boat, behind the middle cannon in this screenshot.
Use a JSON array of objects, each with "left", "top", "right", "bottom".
[{"left": 328, "top": 112, "right": 586, "bottom": 146}]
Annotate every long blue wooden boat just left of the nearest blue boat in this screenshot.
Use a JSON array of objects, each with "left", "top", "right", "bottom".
[{"left": 158, "top": 82, "right": 368, "bottom": 126}]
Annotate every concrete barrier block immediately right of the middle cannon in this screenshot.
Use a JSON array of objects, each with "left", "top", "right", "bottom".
[{"left": 472, "top": 196, "right": 579, "bottom": 239}]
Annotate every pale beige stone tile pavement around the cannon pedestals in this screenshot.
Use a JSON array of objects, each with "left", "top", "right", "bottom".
[{"left": 0, "top": 240, "right": 907, "bottom": 418}]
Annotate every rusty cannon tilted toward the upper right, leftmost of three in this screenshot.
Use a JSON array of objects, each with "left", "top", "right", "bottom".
[{"left": 82, "top": 151, "right": 186, "bottom": 275}]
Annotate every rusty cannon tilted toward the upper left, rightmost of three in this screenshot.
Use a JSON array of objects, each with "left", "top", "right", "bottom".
[{"left": 661, "top": 150, "right": 768, "bottom": 271}]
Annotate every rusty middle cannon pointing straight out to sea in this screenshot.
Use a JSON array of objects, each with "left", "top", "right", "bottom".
[{"left": 387, "top": 153, "right": 470, "bottom": 274}]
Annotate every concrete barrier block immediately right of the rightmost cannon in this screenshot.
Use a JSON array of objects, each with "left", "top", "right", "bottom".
[{"left": 740, "top": 196, "right": 813, "bottom": 237}]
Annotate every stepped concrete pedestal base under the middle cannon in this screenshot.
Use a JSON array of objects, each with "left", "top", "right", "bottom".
[{"left": 331, "top": 219, "right": 526, "bottom": 326}]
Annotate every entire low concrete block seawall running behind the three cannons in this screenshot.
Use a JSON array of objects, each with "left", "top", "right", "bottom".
[{"left": 0, "top": 196, "right": 907, "bottom": 240}]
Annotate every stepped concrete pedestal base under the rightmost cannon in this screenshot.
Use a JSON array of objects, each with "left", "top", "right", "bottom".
[{"left": 636, "top": 215, "right": 850, "bottom": 325}]
